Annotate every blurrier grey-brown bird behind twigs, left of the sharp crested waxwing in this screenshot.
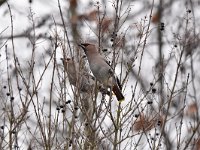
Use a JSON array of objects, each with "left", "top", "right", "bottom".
[{"left": 61, "top": 58, "right": 95, "bottom": 92}]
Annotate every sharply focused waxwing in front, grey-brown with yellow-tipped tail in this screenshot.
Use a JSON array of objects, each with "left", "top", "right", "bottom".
[{"left": 79, "top": 43, "right": 124, "bottom": 102}]
